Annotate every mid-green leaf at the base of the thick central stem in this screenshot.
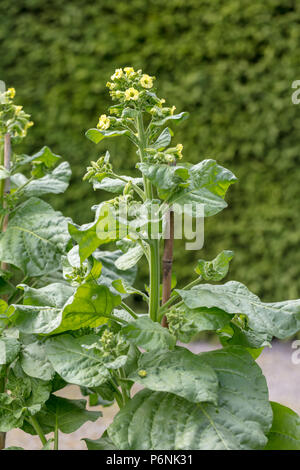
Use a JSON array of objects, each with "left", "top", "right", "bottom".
[{"left": 121, "top": 316, "right": 176, "bottom": 351}]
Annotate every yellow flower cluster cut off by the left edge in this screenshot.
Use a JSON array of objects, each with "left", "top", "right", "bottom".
[{"left": 0, "top": 88, "right": 33, "bottom": 141}]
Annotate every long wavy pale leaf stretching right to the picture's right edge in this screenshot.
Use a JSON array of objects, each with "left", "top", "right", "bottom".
[{"left": 177, "top": 281, "right": 300, "bottom": 339}]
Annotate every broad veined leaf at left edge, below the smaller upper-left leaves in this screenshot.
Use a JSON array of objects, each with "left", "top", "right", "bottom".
[{"left": 0, "top": 198, "right": 70, "bottom": 276}]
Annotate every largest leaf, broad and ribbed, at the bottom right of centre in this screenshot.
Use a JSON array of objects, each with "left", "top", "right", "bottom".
[{"left": 108, "top": 347, "right": 272, "bottom": 450}]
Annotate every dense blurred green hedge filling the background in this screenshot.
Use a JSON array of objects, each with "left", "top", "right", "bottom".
[{"left": 0, "top": 0, "right": 300, "bottom": 300}]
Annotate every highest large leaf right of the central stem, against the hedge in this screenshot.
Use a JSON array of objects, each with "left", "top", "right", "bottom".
[{"left": 168, "top": 160, "right": 236, "bottom": 217}]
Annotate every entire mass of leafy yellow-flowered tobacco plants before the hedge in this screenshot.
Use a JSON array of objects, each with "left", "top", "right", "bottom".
[{"left": 0, "top": 67, "right": 300, "bottom": 450}]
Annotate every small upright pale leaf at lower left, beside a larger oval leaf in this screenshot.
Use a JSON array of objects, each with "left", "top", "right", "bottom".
[{"left": 20, "top": 336, "right": 55, "bottom": 381}]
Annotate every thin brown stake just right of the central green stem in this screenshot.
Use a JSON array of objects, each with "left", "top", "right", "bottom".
[{"left": 162, "top": 210, "right": 174, "bottom": 328}]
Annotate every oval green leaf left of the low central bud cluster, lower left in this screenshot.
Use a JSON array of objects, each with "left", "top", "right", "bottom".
[{"left": 46, "top": 335, "right": 110, "bottom": 387}]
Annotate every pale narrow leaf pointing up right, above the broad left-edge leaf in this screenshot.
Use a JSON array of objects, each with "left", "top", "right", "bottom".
[{"left": 22, "top": 162, "right": 72, "bottom": 197}]
